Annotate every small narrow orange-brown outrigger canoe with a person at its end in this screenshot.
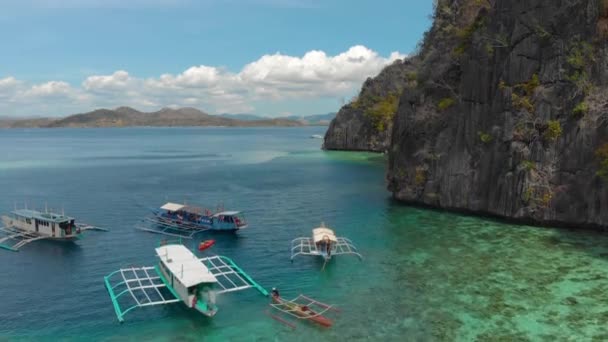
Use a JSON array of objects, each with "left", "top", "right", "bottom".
[{"left": 266, "top": 289, "right": 339, "bottom": 329}]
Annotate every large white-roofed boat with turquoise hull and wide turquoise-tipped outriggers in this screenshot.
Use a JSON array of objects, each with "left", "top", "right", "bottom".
[{"left": 104, "top": 239, "right": 268, "bottom": 323}]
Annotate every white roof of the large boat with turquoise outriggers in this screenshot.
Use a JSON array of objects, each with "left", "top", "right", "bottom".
[{"left": 156, "top": 245, "right": 217, "bottom": 287}]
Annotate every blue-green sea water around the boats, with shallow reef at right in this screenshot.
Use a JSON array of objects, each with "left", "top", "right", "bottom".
[{"left": 0, "top": 127, "right": 608, "bottom": 341}]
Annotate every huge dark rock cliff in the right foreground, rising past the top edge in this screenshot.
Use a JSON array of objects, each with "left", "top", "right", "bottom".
[{"left": 388, "top": 0, "right": 608, "bottom": 227}]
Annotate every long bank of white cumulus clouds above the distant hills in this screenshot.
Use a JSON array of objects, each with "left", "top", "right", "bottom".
[{"left": 0, "top": 45, "right": 405, "bottom": 115}]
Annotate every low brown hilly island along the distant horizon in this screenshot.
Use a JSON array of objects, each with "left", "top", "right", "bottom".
[{"left": 0, "top": 107, "right": 335, "bottom": 128}]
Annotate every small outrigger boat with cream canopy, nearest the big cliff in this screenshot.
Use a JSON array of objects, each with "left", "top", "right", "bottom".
[{"left": 291, "top": 223, "right": 363, "bottom": 262}]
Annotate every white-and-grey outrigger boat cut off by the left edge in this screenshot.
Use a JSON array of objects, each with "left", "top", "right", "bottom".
[{"left": 0, "top": 209, "right": 107, "bottom": 252}]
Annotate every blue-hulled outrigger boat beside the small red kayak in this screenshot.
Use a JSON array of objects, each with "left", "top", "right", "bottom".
[{"left": 136, "top": 202, "right": 247, "bottom": 239}]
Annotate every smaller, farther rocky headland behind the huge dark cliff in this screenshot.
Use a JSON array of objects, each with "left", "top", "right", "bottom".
[{"left": 323, "top": 60, "right": 415, "bottom": 152}]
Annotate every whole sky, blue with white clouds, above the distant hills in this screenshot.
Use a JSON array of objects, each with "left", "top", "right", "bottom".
[{"left": 0, "top": 0, "right": 432, "bottom": 116}]
